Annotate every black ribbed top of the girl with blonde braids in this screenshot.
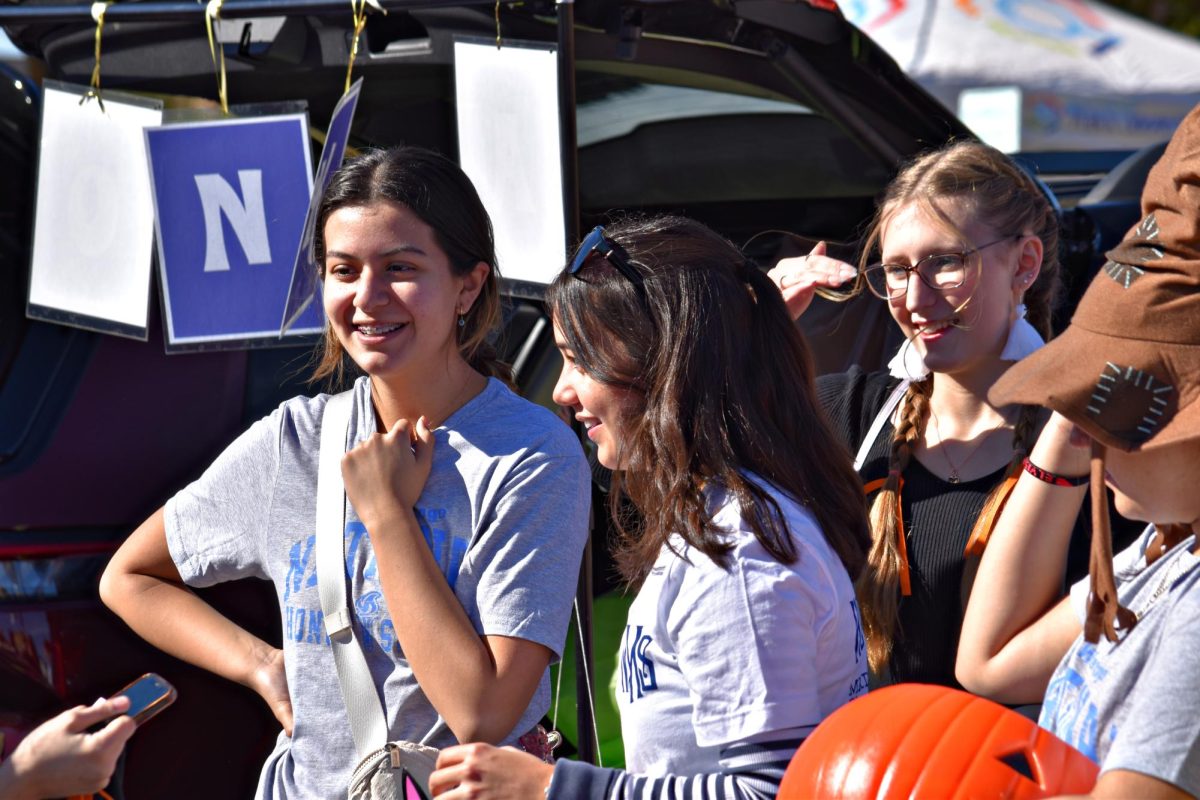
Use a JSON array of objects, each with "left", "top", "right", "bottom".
[{"left": 817, "top": 367, "right": 1088, "bottom": 687}]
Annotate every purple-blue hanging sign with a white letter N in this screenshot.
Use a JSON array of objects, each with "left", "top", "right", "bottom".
[{"left": 145, "top": 114, "right": 323, "bottom": 350}]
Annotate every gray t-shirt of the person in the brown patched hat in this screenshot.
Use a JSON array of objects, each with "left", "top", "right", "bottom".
[{"left": 1038, "top": 525, "right": 1200, "bottom": 796}]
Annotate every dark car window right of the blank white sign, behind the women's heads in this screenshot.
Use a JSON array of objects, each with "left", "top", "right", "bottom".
[{"left": 576, "top": 68, "right": 889, "bottom": 243}]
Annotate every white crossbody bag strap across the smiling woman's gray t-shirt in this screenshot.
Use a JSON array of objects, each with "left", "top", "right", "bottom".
[{"left": 316, "top": 390, "right": 388, "bottom": 758}]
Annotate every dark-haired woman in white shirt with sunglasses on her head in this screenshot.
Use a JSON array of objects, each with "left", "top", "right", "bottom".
[{"left": 430, "top": 217, "right": 868, "bottom": 800}]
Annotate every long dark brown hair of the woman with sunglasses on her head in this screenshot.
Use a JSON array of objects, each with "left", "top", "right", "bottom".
[{"left": 546, "top": 217, "right": 869, "bottom": 583}]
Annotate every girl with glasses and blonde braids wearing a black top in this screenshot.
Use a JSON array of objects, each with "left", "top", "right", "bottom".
[{"left": 770, "top": 142, "right": 1058, "bottom": 686}]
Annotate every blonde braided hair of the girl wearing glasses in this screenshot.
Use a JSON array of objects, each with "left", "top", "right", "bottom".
[{"left": 858, "top": 142, "right": 1060, "bottom": 674}]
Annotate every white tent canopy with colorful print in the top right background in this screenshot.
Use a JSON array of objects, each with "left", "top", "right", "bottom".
[{"left": 839, "top": 0, "right": 1200, "bottom": 150}]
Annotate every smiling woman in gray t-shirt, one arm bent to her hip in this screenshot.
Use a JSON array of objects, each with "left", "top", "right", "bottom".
[{"left": 101, "top": 148, "right": 589, "bottom": 799}]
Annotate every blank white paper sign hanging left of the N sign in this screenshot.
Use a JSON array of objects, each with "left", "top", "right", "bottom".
[{"left": 26, "top": 80, "right": 162, "bottom": 339}]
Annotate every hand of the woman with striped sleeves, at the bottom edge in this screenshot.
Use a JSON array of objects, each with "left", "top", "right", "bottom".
[{"left": 430, "top": 744, "right": 554, "bottom": 800}]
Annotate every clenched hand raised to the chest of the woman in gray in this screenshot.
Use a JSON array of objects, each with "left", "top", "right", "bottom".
[{"left": 342, "top": 416, "right": 433, "bottom": 529}]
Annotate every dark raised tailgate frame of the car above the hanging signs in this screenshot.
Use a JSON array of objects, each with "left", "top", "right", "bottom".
[{"left": 0, "top": 0, "right": 970, "bottom": 166}]
